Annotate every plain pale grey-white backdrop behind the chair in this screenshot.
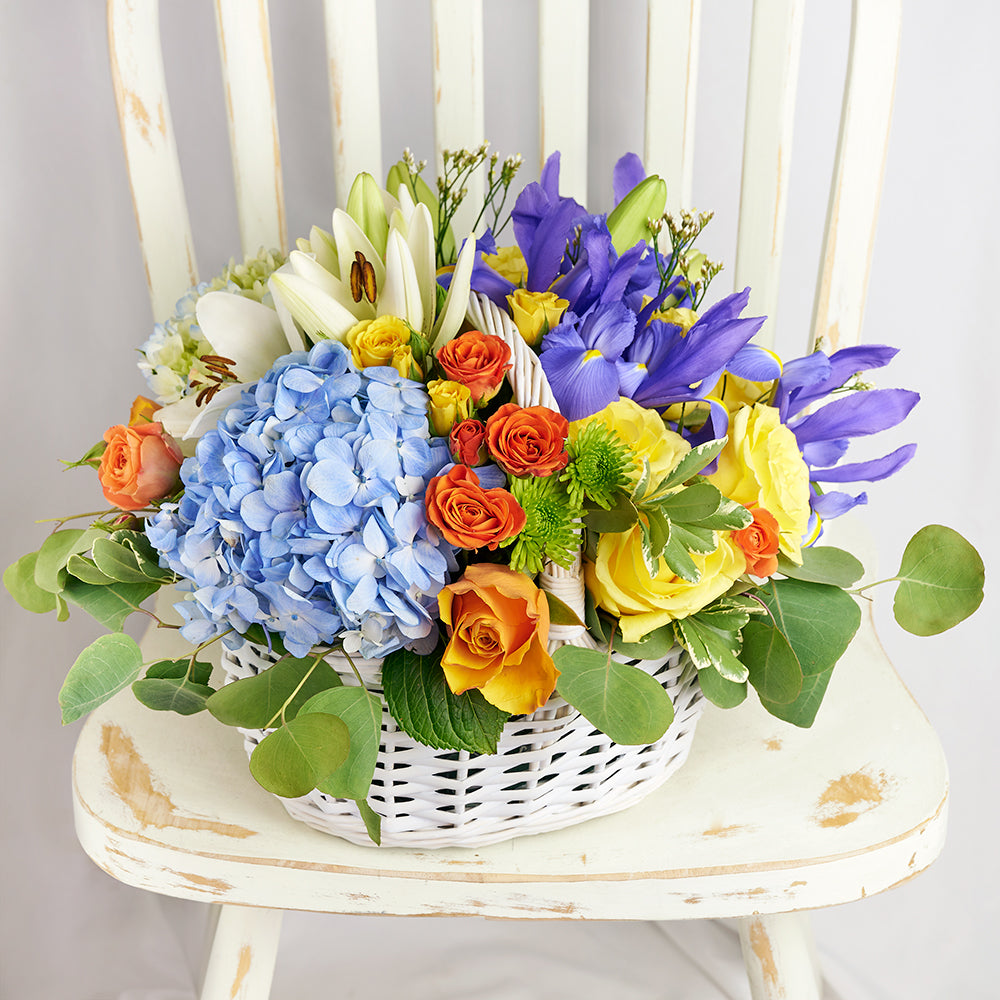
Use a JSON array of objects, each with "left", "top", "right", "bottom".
[{"left": 0, "top": 0, "right": 1000, "bottom": 1000}]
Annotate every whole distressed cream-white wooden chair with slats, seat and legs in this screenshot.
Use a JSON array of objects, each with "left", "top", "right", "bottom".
[{"left": 74, "top": 0, "right": 947, "bottom": 1000}]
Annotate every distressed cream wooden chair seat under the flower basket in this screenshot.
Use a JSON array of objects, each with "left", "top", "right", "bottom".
[{"left": 74, "top": 600, "right": 948, "bottom": 920}]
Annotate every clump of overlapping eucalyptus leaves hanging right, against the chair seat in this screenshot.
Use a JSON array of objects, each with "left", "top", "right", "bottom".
[{"left": 741, "top": 580, "right": 861, "bottom": 727}]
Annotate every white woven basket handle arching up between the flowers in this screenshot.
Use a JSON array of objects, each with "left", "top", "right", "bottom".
[{"left": 466, "top": 292, "right": 597, "bottom": 652}]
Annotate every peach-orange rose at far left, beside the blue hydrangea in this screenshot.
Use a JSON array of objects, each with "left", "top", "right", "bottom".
[{"left": 97, "top": 423, "right": 184, "bottom": 510}]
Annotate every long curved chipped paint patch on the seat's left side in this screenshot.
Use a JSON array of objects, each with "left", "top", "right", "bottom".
[{"left": 101, "top": 722, "right": 255, "bottom": 839}]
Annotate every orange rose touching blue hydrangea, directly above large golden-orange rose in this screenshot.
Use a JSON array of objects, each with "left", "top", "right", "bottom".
[{"left": 424, "top": 465, "right": 527, "bottom": 550}]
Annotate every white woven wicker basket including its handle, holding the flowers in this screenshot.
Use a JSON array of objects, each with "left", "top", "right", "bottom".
[{"left": 222, "top": 294, "right": 702, "bottom": 848}]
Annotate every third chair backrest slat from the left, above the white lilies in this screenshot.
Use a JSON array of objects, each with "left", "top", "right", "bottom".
[{"left": 324, "top": 0, "right": 385, "bottom": 208}]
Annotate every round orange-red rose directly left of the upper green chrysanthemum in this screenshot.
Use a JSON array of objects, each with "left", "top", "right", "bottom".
[{"left": 486, "top": 403, "right": 569, "bottom": 476}]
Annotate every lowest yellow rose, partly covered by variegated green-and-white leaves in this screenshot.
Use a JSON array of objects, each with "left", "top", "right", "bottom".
[{"left": 584, "top": 524, "right": 746, "bottom": 642}]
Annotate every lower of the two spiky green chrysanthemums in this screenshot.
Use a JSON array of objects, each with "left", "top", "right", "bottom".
[{"left": 507, "top": 476, "right": 583, "bottom": 575}]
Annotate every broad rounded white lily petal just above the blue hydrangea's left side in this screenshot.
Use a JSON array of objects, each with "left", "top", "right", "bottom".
[{"left": 195, "top": 292, "right": 288, "bottom": 382}]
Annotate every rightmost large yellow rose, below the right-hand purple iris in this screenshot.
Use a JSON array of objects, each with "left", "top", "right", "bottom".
[{"left": 708, "top": 403, "right": 809, "bottom": 562}]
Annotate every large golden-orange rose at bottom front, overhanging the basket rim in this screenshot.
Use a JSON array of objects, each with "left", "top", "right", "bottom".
[{"left": 438, "top": 563, "right": 559, "bottom": 715}]
